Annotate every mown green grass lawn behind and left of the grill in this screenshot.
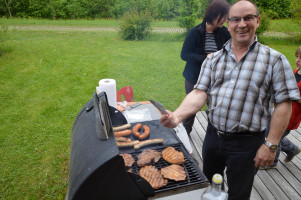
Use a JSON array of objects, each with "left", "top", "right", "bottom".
[{"left": 0, "top": 19, "right": 298, "bottom": 200}]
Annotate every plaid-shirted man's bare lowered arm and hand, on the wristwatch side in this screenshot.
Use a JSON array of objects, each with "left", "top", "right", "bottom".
[{"left": 254, "top": 101, "right": 292, "bottom": 167}]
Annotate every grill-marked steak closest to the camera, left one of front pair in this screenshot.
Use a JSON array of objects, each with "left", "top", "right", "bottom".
[{"left": 139, "top": 166, "right": 168, "bottom": 189}]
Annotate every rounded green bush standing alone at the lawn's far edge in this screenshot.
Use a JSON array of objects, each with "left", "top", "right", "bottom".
[{"left": 120, "top": 9, "right": 152, "bottom": 40}]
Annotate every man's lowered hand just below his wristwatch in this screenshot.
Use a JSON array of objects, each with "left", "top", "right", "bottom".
[{"left": 254, "top": 144, "right": 276, "bottom": 167}]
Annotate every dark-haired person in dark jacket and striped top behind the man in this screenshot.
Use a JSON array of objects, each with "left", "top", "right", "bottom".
[{"left": 181, "top": 0, "right": 231, "bottom": 134}]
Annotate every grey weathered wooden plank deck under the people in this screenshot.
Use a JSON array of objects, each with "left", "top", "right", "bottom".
[{"left": 190, "top": 111, "right": 301, "bottom": 200}]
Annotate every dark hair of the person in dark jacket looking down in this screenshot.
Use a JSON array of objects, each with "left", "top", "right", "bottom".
[{"left": 205, "top": 0, "right": 230, "bottom": 24}]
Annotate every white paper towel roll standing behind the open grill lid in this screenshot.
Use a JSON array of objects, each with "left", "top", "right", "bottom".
[{"left": 96, "top": 79, "right": 117, "bottom": 108}]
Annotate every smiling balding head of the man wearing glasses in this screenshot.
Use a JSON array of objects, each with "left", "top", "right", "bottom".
[{"left": 227, "top": 1, "right": 260, "bottom": 46}]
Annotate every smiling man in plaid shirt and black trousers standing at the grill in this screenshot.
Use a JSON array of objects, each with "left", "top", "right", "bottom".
[{"left": 161, "top": 0, "right": 300, "bottom": 200}]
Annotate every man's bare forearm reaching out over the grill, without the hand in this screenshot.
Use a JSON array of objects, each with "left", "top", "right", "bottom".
[{"left": 174, "top": 89, "right": 208, "bottom": 121}]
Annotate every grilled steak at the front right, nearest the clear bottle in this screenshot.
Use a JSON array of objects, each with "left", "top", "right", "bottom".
[{"left": 161, "top": 164, "right": 186, "bottom": 181}]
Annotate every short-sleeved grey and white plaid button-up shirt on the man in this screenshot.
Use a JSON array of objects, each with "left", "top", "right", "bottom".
[{"left": 195, "top": 38, "right": 300, "bottom": 132}]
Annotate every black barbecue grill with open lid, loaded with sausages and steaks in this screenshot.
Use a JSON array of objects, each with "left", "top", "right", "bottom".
[{"left": 66, "top": 92, "right": 208, "bottom": 200}]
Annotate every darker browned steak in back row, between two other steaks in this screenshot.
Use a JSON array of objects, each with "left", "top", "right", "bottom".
[{"left": 137, "top": 149, "right": 161, "bottom": 167}]
